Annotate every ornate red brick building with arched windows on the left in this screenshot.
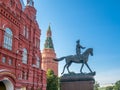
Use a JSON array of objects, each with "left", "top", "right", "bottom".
[{"left": 0, "top": 0, "right": 46, "bottom": 90}]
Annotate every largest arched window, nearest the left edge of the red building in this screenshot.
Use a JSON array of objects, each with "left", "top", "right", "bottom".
[{"left": 4, "top": 28, "right": 13, "bottom": 50}]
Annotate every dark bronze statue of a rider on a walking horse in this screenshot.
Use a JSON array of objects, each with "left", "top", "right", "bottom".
[{"left": 53, "top": 40, "right": 95, "bottom": 74}]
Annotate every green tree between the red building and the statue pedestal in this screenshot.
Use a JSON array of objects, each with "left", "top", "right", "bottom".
[{"left": 47, "top": 69, "right": 58, "bottom": 90}]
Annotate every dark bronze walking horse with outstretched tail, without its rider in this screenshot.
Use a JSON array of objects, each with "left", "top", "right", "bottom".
[{"left": 53, "top": 48, "right": 93, "bottom": 74}]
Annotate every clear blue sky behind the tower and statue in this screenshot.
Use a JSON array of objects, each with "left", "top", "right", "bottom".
[{"left": 23, "top": 0, "right": 120, "bottom": 84}]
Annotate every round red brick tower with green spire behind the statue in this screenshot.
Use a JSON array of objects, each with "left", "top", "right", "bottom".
[{"left": 42, "top": 25, "right": 58, "bottom": 75}]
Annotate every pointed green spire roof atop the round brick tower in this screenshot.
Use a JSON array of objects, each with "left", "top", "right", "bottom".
[{"left": 44, "top": 25, "right": 54, "bottom": 50}]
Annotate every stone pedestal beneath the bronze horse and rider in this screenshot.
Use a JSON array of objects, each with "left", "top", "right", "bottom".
[{"left": 60, "top": 74, "right": 95, "bottom": 90}]
